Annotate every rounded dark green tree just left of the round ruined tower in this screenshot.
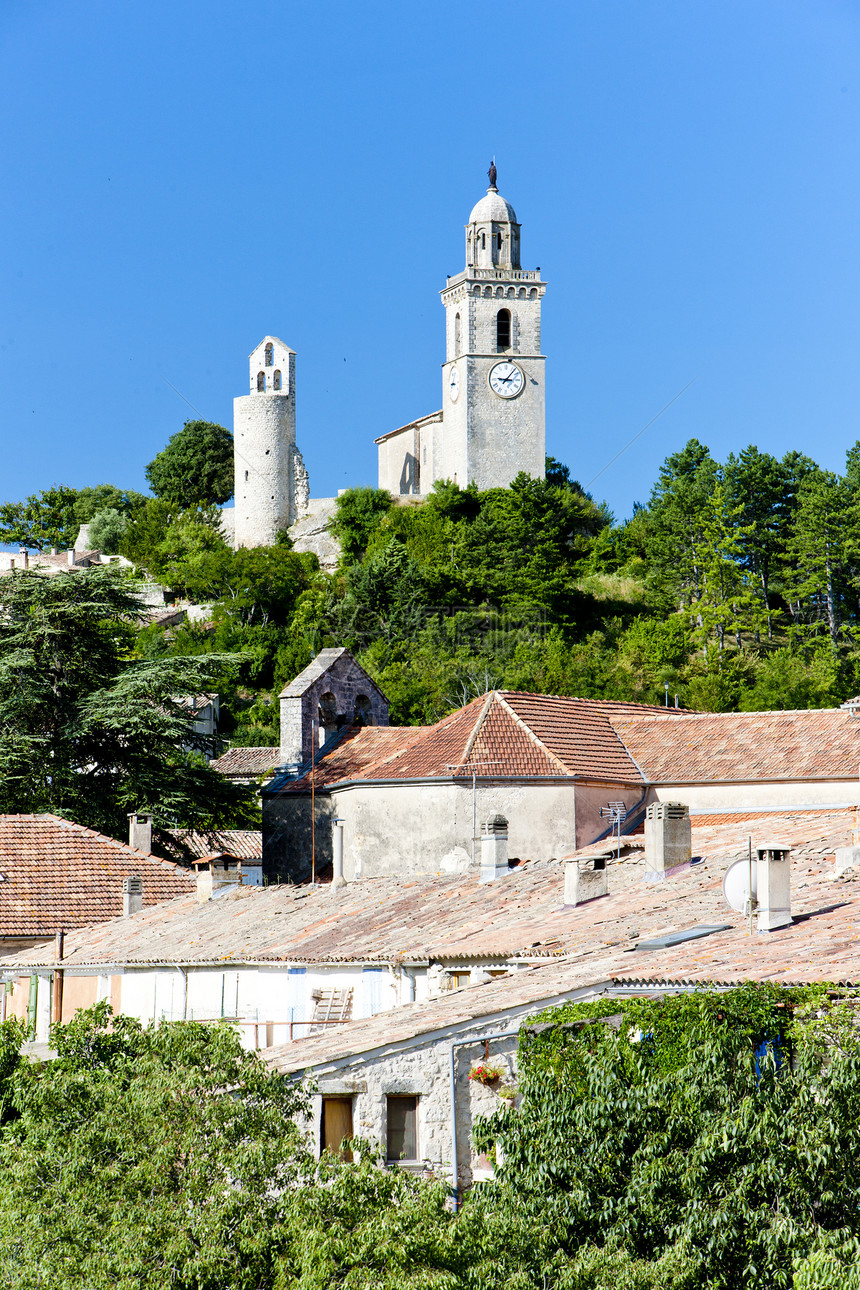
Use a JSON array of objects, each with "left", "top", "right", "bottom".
[{"left": 146, "top": 421, "right": 233, "bottom": 508}]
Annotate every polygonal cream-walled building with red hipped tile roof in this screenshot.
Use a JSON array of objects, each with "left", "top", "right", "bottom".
[{"left": 263, "top": 686, "right": 679, "bottom": 882}]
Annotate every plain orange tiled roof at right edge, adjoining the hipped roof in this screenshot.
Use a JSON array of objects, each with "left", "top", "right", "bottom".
[{"left": 611, "top": 708, "right": 860, "bottom": 784}]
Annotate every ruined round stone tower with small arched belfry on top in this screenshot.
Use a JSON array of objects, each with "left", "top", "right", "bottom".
[{"left": 233, "top": 335, "right": 308, "bottom": 547}]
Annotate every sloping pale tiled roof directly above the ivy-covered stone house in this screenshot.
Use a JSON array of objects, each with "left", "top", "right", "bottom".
[{"left": 269, "top": 817, "right": 860, "bottom": 1072}]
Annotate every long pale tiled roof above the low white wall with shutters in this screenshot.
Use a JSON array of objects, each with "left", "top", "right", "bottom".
[{"left": 1, "top": 810, "right": 860, "bottom": 966}]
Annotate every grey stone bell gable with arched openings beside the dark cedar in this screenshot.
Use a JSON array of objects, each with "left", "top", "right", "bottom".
[{"left": 281, "top": 649, "right": 388, "bottom": 768}]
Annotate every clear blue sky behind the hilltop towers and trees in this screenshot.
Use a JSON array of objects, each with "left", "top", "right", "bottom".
[{"left": 0, "top": 0, "right": 860, "bottom": 517}]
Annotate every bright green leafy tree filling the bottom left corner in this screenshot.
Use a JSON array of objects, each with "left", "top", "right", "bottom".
[{"left": 0, "top": 1004, "right": 318, "bottom": 1290}]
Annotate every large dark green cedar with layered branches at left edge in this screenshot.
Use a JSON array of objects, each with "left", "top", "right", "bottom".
[{"left": 0, "top": 566, "right": 255, "bottom": 842}]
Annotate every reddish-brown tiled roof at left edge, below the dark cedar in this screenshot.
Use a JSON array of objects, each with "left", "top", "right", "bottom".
[{"left": 0, "top": 815, "right": 193, "bottom": 938}]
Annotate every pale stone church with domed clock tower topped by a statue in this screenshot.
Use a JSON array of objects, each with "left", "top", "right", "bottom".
[{"left": 376, "top": 165, "right": 547, "bottom": 494}]
